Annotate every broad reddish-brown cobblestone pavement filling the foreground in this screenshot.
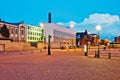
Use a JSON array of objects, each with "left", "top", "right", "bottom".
[{"left": 0, "top": 51, "right": 120, "bottom": 80}]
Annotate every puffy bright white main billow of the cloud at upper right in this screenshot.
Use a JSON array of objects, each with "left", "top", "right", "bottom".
[{"left": 81, "top": 13, "right": 120, "bottom": 24}]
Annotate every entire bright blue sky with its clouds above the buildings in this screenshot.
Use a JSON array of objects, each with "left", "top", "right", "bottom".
[{"left": 0, "top": 0, "right": 120, "bottom": 41}]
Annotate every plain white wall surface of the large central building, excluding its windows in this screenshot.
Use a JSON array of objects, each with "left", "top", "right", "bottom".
[{"left": 43, "top": 23, "right": 76, "bottom": 48}]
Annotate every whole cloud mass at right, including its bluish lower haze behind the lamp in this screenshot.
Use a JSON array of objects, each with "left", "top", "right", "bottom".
[{"left": 56, "top": 13, "right": 120, "bottom": 40}]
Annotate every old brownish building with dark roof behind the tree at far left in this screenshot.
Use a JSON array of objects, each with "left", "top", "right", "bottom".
[{"left": 0, "top": 19, "right": 26, "bottom": 42}]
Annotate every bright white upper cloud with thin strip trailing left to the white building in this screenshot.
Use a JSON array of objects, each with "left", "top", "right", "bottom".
[{"left": 57, "top": 13, "right": 120, "bottom": 27}]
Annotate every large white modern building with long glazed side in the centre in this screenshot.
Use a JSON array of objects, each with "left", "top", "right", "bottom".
[{"left": 43, "top": 23, "right": 76, "bottom": 48}]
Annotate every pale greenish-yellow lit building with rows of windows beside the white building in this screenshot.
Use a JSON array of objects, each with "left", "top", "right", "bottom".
[{"left": 26, "top": 25, "right": 43, "bottom": 42}]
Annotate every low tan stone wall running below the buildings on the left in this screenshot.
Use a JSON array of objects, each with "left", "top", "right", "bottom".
[{"left": 0, "top": 40, "right": 48, "bottom": 51}]
